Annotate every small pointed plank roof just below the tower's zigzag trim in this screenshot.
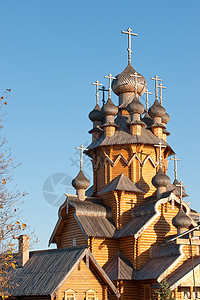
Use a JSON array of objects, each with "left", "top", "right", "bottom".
[{"left": 98, "top": 174, "right": 145, "bottom": 195}]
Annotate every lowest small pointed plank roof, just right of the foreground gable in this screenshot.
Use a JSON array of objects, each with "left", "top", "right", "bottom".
[{"left": 104, "top": 251, "right": 136, "bottom": 280}]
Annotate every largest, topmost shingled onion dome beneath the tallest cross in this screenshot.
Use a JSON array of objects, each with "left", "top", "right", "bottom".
[{"left": 112, "top": 63, "right": 147, "bottom": 96}]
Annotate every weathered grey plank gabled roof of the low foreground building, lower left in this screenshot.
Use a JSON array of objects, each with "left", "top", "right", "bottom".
[{"left": 8, "top": 248, "right": 120, "bottom": 297}]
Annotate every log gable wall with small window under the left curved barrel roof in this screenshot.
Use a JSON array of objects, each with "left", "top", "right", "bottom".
[{"left": 57, "top": 205, "right": 88, "bottom": 248}]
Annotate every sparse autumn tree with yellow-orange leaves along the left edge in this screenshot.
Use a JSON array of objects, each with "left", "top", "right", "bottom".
[{"left": 0, "top": 89, "right": 26, "bottom": 298}]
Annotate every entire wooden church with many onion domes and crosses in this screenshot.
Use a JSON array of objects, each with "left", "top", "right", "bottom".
[{"left": 10, "top": 28, "right": 200, "bottom": 300}]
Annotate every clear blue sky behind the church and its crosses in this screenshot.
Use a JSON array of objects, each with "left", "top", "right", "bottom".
[{"left": 0, "top": 0, "right": 200, "bottom": 248}]
